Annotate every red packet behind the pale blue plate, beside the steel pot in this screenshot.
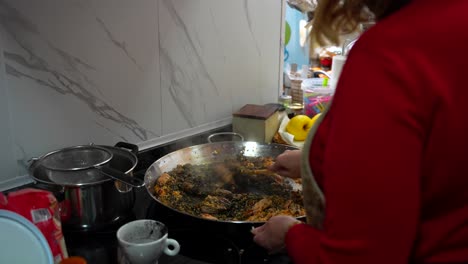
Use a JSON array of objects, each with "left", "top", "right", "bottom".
[{"left": 0, "top": 189, "right": 68, "bottom": 263}]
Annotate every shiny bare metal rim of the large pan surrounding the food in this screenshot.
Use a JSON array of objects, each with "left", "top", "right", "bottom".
[{"left": 145, "top": 141, "right": 300, "bottom": 224}]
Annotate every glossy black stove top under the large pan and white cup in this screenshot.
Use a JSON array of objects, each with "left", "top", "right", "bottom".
[{"left": 64, "top": 127, "right": 292, "bottom": 264}]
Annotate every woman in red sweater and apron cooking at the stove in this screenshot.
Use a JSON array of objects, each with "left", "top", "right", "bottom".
[{"left": 253, "top": 0, "right": 468, "bottom": 264}]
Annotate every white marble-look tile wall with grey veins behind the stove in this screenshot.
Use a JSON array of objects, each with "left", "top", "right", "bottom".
[{"left": 0, "top": 0, "right": 284, "bottom": 188}]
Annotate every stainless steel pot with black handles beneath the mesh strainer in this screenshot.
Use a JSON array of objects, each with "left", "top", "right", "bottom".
[{"left": 29, "top": 142, "right": 138, "bottom": 230}]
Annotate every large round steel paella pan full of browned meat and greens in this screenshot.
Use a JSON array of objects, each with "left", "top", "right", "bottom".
[{"left": 145, "top": 141, "right": 305, "bottom": 223}]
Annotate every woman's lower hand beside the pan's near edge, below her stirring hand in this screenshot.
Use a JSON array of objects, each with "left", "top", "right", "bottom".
[{"left": 252, "top": 215, "right": 301, "bottom": 254}]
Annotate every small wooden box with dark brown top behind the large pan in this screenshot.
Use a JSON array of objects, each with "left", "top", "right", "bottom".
[{"left": 232, "top": 104, "right": 280, "bottom": 143}]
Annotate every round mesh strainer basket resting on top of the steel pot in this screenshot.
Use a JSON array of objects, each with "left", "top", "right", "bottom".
[{"left": 41, "top": 145, "right": 112, "bottom": 171}]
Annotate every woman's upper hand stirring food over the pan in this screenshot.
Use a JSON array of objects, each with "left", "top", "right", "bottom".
[{"left": 268, "top": 150, "right": 302, "bottom": 179}]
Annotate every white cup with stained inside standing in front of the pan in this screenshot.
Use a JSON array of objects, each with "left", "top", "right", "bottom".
[{"left": 117, "top": 219, "right": 180, "bottom": 264}]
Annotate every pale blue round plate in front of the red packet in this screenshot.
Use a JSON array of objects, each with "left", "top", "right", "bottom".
[{"left": 0, "top": 210, "right": 54, "bottom": 264}]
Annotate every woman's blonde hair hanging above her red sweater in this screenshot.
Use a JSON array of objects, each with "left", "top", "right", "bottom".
[{"left": 310, "top": 0, "right": 411, "bottom": 47}]
